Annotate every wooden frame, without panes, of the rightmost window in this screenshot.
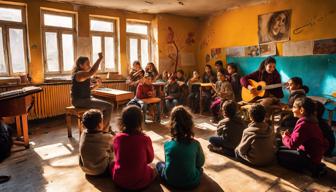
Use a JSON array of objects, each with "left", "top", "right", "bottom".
[{"left": 126, "top": 19, "right": 152, "bottom": 69}]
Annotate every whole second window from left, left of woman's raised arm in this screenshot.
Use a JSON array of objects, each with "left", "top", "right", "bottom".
[{"left": 42, "top": 10, "right": 76, "bottom": 74}]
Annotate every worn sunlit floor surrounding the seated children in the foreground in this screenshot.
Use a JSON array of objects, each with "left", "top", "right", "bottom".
[{"left": 0, "top": 114, "right": 336, "bottom": 192}]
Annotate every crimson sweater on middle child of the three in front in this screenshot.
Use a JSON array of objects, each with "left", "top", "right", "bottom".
[{"left": 111, "top": 133, "right": 154, "bottom": 190}]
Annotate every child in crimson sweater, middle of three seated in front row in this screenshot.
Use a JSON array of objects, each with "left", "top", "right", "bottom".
[{"left": 111, "top": 105, "right": 156, "bottom": 190}]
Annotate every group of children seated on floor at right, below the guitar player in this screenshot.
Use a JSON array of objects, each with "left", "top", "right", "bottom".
[{"left": 208, "top": 97, "right": 335, "bottom": 177}]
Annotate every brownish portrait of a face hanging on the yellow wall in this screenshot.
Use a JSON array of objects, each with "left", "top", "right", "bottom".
[{"left": 258, "top": 10, "right": 291, "bottom": 44}]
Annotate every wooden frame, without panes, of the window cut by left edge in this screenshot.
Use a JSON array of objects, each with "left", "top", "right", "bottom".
[{"left": 0, "top": 4, "right": 29, "bottom": 77}]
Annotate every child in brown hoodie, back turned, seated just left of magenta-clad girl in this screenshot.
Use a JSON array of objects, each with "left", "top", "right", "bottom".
[{"left": 235, "top": 104, "right": 275, "bottom": 166}]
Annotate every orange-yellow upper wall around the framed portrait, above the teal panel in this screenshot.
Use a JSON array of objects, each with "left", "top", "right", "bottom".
[{"left": 197, "top": 0, "right": 336, "bottom": 71}]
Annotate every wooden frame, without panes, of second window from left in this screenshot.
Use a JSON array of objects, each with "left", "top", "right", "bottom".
[{"left": 40, "top": 8, "right": 77, "bottom": 76}]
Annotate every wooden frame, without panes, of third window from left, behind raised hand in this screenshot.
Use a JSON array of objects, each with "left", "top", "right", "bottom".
[{"left": 89, "top": 15, "right": 120, "bottom": 73}]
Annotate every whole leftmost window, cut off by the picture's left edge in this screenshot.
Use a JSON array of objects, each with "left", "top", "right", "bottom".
[{"left": 0, "top": 5, "right": 28, "bottom": 76}]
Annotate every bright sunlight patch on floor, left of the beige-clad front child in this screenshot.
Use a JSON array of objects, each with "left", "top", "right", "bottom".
[{"left": 34, "top": 143, "right": 71, "bottom": 160}]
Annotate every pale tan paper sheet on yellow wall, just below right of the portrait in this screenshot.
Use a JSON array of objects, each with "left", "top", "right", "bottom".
[{"left": 283, "top": 41, "right": 314, "bottom": 56}]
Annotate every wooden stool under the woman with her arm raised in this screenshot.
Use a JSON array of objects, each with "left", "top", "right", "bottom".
[{"left": 65, "top": 106, "right": 88, "bottom": 137}]
